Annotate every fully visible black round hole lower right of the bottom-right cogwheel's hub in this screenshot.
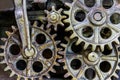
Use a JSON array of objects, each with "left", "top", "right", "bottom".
[{"left": 100, "top": 61, "right": 111, "bottom": 73}]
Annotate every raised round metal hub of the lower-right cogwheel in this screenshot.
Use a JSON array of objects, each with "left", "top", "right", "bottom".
[{"left": 84, "top": 52, "right": 100, "bottom": 65}]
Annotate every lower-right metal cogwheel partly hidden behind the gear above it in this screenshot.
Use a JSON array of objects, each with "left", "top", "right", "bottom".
[{"left": 59, "top": 39, "right": 120, "bottom": 80}]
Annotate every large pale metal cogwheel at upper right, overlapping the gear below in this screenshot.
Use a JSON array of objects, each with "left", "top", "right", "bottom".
[{"left": 63, "top": 0, "right": 120, "bottom": 51}]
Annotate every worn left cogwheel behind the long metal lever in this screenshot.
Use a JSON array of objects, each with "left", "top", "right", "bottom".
[{"left": 0, "top": 22, "right": 61, "bottom": 80}]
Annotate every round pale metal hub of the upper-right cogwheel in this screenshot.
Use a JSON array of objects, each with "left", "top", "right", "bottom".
[{"left": 89, "top": 9, "right": 106, "bottom": 25}]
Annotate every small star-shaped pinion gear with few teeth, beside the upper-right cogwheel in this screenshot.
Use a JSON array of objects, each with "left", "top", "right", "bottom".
[{"left": 45, "top": 6, "right": 66, "bottom": 30}]
